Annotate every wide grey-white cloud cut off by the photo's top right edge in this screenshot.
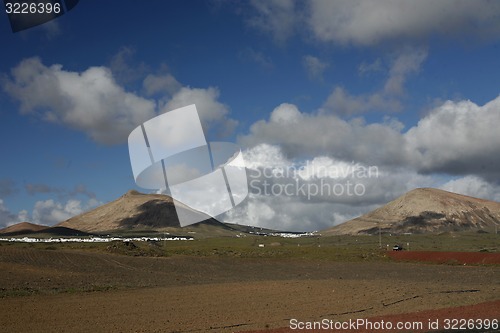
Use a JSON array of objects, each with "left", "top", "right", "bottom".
[{"left": 306, "top": 0, "right": 500, "bottom": 45}]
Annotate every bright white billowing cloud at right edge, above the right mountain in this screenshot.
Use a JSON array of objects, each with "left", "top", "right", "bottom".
[{"left": 405, "top": 97, "right": 500, "bottom": 181}]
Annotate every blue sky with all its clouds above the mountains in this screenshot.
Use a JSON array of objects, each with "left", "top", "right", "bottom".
[{"left": 0, "top": 0, "right": 500, "bottom": 230}]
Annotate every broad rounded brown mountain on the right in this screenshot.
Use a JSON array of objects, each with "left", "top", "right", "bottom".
[{"left": 322, "top": 188, "right": 500, "bottom": 235}]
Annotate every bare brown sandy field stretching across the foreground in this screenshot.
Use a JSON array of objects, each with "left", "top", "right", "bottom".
[{"left": 0, "top": 246, "right": 500, "bottom": 332}]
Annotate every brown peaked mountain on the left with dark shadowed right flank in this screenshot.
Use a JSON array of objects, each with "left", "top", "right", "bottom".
[{"left": 57, "top": 191, "right": 230, "bottom": 233}]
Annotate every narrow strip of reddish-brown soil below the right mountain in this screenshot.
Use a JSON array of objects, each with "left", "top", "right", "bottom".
[{"left": 387, "top": 251, "right": 500, "bottom": 265}]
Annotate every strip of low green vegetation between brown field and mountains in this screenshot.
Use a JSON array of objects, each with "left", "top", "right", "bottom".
[{"left": 0, "top": 232, "right": 500, "bottom": 261}]
